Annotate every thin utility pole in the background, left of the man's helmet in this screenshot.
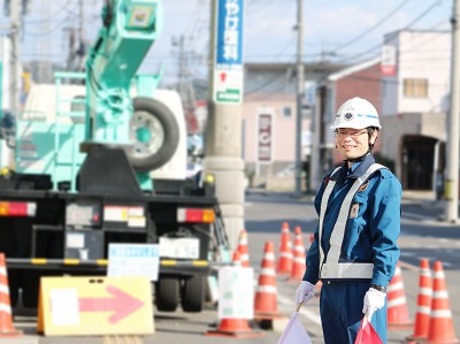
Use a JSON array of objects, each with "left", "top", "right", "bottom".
[{"left": 295, "top": 0, "right": 305, "bottom": 196}]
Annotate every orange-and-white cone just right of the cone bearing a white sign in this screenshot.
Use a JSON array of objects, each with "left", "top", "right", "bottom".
[{"left": 254, "top": 241, "right": 280, "bottom": 319}]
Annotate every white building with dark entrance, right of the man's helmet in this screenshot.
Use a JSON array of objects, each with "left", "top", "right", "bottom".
[{"left": 381, "top": 31, "right": 451, "bottom": 190}]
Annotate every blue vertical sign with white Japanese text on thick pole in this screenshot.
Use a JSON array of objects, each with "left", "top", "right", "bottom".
[{"left": 216, "top": 0, "right": 243, "bottom": 67}]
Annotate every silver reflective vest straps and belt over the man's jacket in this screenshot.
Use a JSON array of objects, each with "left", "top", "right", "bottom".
[{"left": 318, "top": 164, "right": 385, "bottom": 279}]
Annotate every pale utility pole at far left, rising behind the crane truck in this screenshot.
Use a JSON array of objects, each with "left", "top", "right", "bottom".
[{"left": 7, "top": 0, "right": 22, "bottom": 116}]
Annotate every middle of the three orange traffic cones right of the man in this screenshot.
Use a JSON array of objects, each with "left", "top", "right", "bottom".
[{"left": 406, "top": 258, "right": 433, "bottom": 342}]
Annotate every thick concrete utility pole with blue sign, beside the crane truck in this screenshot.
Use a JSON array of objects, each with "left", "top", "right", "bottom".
[{"left": 203, "top": 0, "right": 244, "bottom": 249}]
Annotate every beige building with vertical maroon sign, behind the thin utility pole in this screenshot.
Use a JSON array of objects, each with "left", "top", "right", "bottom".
[{"left": 242, "top": 62, "right": 343, "bottom": 191}]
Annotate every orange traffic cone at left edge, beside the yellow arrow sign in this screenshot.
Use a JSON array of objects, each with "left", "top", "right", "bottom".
[{"left": 0, "top": 253, "right": 22, "bottom": 338}]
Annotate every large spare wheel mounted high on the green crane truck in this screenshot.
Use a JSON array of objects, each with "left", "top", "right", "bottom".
[{"left": 128, "top": 97, "right": 179, "bottom": 172}]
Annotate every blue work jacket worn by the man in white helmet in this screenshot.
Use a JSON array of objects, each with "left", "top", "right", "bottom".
[{"left": 303, "top": 154, "right": 402, "bottom": 286}]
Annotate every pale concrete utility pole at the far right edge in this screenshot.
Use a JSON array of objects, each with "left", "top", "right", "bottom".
[{"left": 444, "top": 0, "right": 460, "bottom": 222}]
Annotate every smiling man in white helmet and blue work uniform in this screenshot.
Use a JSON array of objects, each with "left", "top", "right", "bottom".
[{"left": 295, "top": 97, "right": 402, "bottom": 344}]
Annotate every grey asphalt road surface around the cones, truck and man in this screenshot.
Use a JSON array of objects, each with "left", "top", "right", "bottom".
[{"left": 6, "top": 193, "right": 460, "bottom": 344}]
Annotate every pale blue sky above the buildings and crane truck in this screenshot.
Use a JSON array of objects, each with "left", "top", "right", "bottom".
[{"left": 0, "top": 0, "right": 455, "bottom": 83}]
